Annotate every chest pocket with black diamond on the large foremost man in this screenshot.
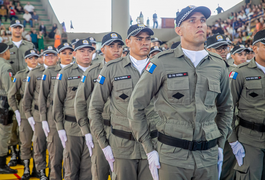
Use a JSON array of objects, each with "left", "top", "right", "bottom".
[{"left": 167, "top": 77, "right": 191, "bottom": 104}]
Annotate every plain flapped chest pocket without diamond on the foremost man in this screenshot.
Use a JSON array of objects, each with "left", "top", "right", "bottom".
[{"left": 204, "top": 79, "right": 221, "bottom": 106}]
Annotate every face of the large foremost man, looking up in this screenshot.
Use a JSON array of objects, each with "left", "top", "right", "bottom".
[{"left": 175, "top": 12, "right": 207, "bottom": 46}]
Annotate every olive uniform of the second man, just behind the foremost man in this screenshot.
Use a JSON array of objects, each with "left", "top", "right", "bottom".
[{"left": 89, "top": 56, "right": 159, "bottom": 179}]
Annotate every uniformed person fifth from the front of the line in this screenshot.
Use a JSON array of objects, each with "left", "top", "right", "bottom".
[{"left": 39, "top": 43, "right": 74, "bottom": 180}]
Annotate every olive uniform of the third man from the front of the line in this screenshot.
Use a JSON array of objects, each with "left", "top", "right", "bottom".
[{"left": 75, "top": 61, "right": 110, "bottom": 180}]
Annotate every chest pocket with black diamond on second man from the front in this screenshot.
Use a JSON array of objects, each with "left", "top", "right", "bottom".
[{"left": 113, "top": 79, "right": 132, "bottom": 103}]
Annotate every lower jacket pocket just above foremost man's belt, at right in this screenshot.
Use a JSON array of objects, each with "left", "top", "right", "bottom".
[{"left": 202, "top": 123, "right": 222, "bottom": 141}]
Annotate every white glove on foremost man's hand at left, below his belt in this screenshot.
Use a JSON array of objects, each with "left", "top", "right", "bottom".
[{"left": 146, "top": 150, "right": 160, "bottom": 180}]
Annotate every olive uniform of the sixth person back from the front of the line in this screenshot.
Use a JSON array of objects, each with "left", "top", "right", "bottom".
[{"left": 22, "top": 65, "right": 47, "bottom": 171}]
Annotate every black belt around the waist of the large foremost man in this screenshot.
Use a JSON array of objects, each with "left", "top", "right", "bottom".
[{"left": 158, "top": 132, "right": 217, "bottom": 151}]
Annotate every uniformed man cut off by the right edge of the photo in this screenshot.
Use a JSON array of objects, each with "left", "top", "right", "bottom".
[{"left": 228, "top": 30, "right": 265, "bottom": 180}]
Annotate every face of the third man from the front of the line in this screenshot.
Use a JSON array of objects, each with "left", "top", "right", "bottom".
[{"left": 101, "top": 42, "right": 123, "bottom": 61}]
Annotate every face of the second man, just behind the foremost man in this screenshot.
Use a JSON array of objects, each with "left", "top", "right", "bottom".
[{"left": 126, "top": 32, "right": 151, "bottom": 57}]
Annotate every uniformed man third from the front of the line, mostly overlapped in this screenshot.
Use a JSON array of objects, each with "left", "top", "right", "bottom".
[{"left": 75, "top": 32, "right": 124, "bottom": 180}]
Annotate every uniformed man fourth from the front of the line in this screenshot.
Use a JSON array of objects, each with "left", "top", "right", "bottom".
[{"left": 52, "top": 40, "right": 95, "bottom": 180}]
